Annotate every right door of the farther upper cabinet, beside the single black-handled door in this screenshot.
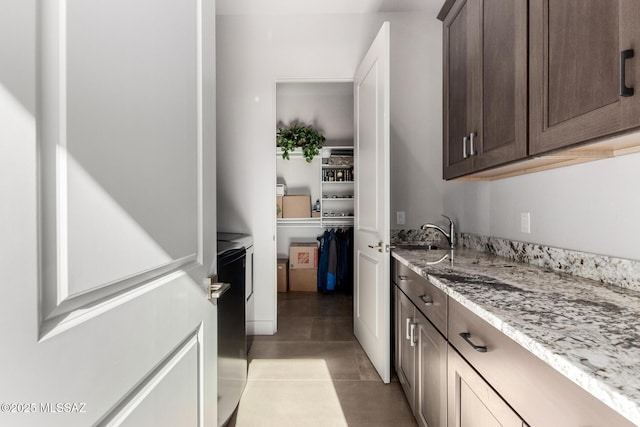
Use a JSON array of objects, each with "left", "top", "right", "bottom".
[{"left": 470, "top": 0, "right": 527, "bottom": 171}]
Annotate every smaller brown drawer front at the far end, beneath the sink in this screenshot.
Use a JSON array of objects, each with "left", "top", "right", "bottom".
[{"left": 394, "top": 261, "right": 447, "bottom": 338}]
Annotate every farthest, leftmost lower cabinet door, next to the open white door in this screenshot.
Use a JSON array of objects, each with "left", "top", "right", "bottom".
[{"left": 396, "top": 288, "right": 417, "bottom": 409}]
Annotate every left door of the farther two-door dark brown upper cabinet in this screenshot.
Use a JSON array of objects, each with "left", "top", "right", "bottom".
[{"left": 443, "top": 0, "right": 477, "bottom": 179}]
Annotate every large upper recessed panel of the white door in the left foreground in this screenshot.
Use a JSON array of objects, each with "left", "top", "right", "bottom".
[{"left": 65, "top": 0, "right": 202, "bottom": 296}]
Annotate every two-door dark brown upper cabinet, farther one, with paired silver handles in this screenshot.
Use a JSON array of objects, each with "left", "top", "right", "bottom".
[{"left": 439, "top": 0, "right": 527, "bottom": 179}]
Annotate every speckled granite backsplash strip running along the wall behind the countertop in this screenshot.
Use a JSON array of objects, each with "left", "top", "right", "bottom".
[{"left": 391, "top": 230, "right": 640, "bottom": 291}]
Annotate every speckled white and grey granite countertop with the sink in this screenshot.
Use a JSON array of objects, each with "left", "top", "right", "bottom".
[{"left": 393, "top": 249, "right": 640, "bottom": 425}]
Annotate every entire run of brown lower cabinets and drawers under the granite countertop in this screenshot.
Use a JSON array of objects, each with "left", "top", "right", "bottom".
[{"left": 392, "top": 261, "right": 635, "bottom": 427}]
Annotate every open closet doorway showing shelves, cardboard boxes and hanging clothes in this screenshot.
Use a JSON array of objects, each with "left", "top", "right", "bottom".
[{"left": 275, "top": 80, "right": 357, "bottom": 332}]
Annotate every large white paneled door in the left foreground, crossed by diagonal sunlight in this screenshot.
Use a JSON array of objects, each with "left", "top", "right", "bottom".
[{"left": 0, "top": 0, "right": 217, "bottom": 426}]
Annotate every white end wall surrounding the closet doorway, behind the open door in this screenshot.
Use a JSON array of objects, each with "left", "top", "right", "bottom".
[{"left": 217, "top": 10, "right": 443, "bottom": 333}]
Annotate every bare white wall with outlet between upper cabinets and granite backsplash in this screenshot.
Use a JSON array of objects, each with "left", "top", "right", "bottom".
[{"left": 444, "top": 154, "right": 640, "bottom": 260}]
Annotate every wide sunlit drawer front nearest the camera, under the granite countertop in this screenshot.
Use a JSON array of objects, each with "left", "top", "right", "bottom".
[{"left": 449, "top": 299, "right": 633, "bottom": 427}]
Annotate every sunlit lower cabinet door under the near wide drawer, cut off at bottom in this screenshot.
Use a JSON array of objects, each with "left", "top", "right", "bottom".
[{"left": 447, "top": 346, "right": 524, "bottom": 427}]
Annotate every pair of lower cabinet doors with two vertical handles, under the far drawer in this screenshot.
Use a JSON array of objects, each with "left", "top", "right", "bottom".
[{"left": 395, "top": 287, "right": 447, "bottom": 427}]
